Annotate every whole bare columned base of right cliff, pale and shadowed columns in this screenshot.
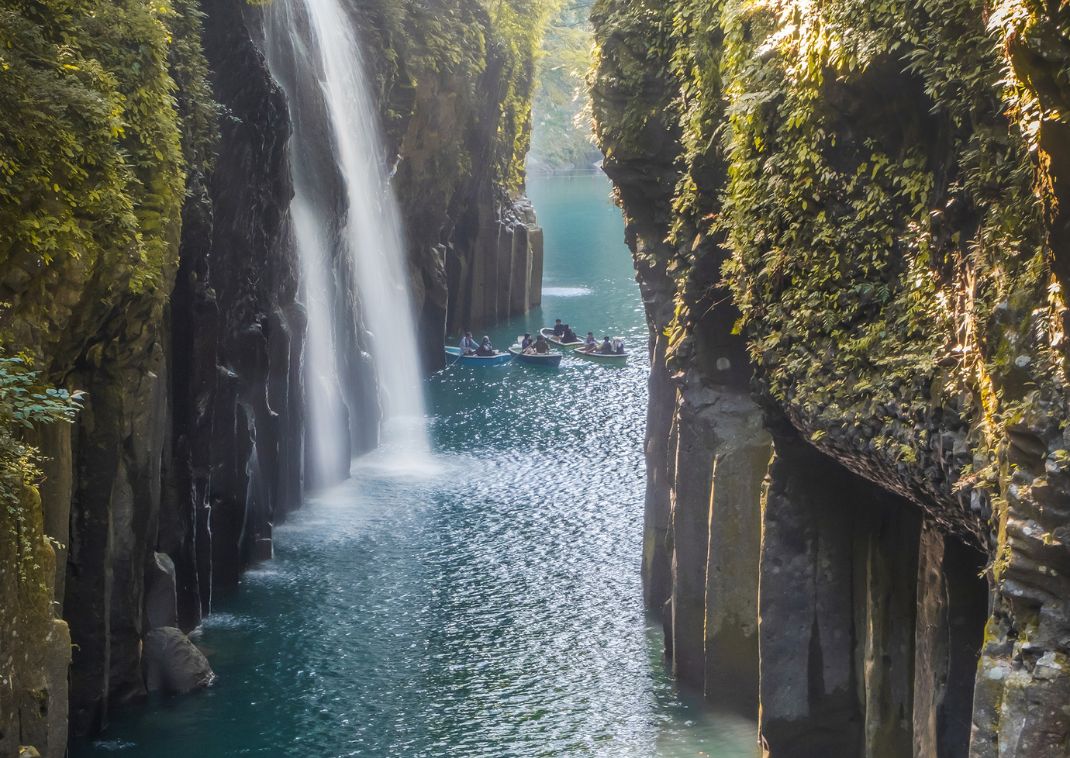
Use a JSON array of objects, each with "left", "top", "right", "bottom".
[{"left": 644, "top": 374, "right": 988, "bottom": 758}]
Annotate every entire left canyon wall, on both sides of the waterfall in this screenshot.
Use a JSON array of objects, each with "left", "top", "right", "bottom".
[{"left": 0, "top": 0, "right": 541, "bottom": 756}]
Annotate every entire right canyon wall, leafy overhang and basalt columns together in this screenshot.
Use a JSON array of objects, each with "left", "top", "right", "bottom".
[{"left": 592, "top": 0, "right": 1070, "bottom": 758}]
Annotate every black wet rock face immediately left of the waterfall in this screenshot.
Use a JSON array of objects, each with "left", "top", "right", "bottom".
[{"left": 176, "top": 2, "right": 304, "bottom": 599}]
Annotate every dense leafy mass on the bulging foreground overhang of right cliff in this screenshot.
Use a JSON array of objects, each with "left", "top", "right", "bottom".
[{"left": 721, "top": 1, "right": 1064, "bottom": 511}]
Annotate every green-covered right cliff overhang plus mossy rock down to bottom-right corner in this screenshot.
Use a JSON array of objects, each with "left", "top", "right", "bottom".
[{"left": 594, "top": 0, "right": 1070, "bottom": 755}]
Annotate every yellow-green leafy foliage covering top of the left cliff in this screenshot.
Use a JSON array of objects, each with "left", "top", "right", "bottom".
[{"left": 0, "top": 0, "right": 192, "bottom": 351}]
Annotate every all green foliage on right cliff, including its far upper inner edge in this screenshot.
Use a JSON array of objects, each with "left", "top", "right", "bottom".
[{"left": 594, "top": 0, "right": 1070, "bottom": 539}]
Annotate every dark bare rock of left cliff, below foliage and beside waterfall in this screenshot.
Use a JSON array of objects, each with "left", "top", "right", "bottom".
[{"left": 58, "top": 2, "right": 302, "bottom": 731}]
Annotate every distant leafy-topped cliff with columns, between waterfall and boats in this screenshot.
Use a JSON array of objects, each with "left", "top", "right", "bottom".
[{"left": 356, "top": 0, "right": 542, "bottom": 363}]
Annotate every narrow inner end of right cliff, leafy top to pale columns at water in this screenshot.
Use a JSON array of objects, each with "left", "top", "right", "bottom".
[{"left": 593, "top": 2, "right": 770, "bottom": 716}]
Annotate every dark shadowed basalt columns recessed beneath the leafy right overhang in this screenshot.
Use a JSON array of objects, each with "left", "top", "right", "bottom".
[{"left": 760, "top": 417, "right": 988, "bottom": 758}]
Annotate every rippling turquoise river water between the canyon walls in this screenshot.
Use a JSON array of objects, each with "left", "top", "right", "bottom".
[{"left": 75, "top": 176, "right": 756, "bottom": 758}]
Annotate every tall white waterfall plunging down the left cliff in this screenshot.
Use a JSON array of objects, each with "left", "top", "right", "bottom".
[{"left": 264, "top": 0, "right": 428, "bottom": 483}]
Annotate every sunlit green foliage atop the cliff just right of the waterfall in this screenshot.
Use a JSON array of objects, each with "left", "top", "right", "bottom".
[{"left": 358, "top": 0, "right": 559, "bottom": 201}]
